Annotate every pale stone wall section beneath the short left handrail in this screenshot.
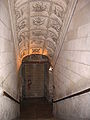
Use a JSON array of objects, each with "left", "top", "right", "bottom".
[{"left": 0, "top": 96, "right": 20, "bottom": 120}]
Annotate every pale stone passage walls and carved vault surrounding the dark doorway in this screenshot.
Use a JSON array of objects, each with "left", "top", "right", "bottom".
[{"left": 0, "top": 0, "right": 90, "bottom": 120}]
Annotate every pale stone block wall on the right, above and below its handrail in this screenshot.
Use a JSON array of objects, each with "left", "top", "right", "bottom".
[{"left": 54, "top": 0, "right": 90, "bottom": 120}]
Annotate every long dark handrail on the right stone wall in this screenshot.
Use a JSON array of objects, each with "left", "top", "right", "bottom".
[{"left": 53, "top": 88, "right": 90, "bottom": 103}]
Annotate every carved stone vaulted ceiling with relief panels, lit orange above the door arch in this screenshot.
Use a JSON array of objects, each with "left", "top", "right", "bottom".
[{"left": 9, "top": 0, "right": 68, "bottom": 59}]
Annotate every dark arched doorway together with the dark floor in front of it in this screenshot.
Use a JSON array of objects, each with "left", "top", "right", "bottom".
[{"left": 20, "top": 55, "right": 53, "bottom": 120}]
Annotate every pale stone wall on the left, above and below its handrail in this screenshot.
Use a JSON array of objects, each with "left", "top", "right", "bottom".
[{"left": 0, "top": 0, "right": 19, "bottom": 120}]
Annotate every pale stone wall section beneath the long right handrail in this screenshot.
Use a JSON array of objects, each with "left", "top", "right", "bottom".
[{"left": 54, "top": 93, "right": 90, "bottom": 120}]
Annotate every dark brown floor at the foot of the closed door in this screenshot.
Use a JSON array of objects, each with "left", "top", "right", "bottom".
[{"left": 15, "top": 98, "right": 54, "bottom": 120}]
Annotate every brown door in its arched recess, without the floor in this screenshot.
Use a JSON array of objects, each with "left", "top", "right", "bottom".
[{"left": 20, "top": 54, "right": 53, "bottom": 99}]
